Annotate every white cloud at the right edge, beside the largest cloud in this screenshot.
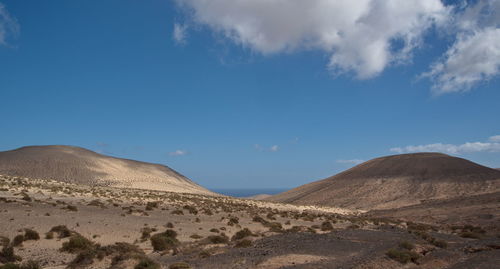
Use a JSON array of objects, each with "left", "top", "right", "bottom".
[{"left": 423, "top": 0, "right": 500, "bottom": 94}]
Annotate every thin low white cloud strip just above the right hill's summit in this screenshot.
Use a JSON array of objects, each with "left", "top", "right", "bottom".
[{"left": 390, "top": 135, "right": 500, "bottom": 154}]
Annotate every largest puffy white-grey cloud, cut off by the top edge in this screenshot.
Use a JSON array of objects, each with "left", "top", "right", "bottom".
[{"left": 177, "top": 0, "right": 449, "bottom": 79}]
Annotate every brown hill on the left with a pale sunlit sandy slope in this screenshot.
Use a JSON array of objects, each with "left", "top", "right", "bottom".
[{"left": 0, "top": 146, "right": 213, "bottom": 194}]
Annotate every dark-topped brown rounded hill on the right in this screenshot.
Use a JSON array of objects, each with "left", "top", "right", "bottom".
[{"left": 266, "top": 153, "right": 500, "bottom": 210}]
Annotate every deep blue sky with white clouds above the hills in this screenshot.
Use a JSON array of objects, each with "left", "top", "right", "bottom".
[{"left": 0, "top": 0, "right": 500, "bottom": 188}]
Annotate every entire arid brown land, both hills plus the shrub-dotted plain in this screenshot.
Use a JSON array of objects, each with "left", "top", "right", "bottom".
[{"left": 0, "top": 146, "right": 500, "bottom": 269}]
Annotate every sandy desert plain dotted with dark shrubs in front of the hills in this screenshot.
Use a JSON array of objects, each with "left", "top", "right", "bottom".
[{"left": 0, "top": 173, "right": 500, "bottom": 269}]
